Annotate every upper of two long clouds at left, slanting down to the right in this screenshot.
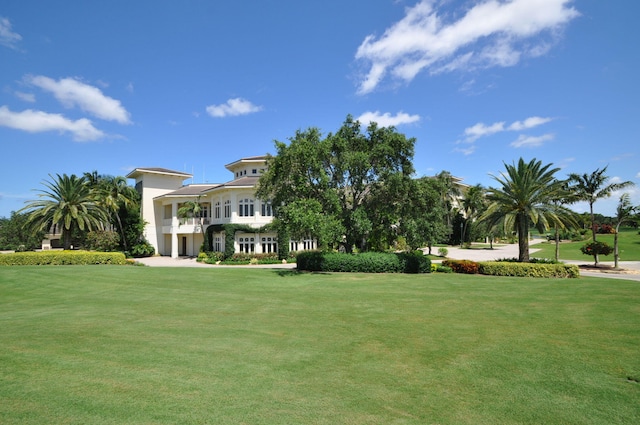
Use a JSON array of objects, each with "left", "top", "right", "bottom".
[{"left": 26, "top": 75, "right": 131, "bottom": 124}]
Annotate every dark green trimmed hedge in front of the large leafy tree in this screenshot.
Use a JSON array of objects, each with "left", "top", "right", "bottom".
[{"left": 297, "top": 251, "right": 431, "bottom": 273}]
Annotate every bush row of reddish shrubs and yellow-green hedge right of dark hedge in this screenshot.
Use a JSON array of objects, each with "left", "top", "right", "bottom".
[{"left": 442, "top": 260, "right": 580, "bottom": 278}]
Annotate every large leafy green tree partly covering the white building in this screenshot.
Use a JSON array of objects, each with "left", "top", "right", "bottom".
[{"left": 257, "top": 116, "right": 415, "bottom": 252}]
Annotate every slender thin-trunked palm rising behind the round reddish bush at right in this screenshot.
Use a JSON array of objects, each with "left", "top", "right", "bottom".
[{"left": 569, "top": 165, "right": 634, "bottom": 242}]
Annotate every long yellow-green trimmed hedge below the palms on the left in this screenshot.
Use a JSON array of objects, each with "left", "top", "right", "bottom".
[{"left": 0, "top": 251, "right": 129, "bottom": 266}]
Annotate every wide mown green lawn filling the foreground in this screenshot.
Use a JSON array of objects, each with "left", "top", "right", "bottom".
[{"left": 0, "top": 266, "right": 640, "bottom": 425}]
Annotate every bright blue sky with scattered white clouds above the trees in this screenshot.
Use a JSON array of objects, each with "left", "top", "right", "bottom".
[{"left": 0, "top": 0, "right": 640, "bottom": 217}]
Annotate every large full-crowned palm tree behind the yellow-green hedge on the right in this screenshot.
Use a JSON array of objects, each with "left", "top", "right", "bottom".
[{"left": 480, "top": 158, "right": 570, "bottom": 262}]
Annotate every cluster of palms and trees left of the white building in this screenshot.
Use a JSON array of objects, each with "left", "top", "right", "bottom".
[{"left": 0, "top": 171, "right": 153, "bottom": 255}]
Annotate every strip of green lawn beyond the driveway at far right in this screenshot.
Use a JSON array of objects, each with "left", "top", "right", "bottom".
[{"left": 531, "top": 229, "right": 640, "bottom": 263}]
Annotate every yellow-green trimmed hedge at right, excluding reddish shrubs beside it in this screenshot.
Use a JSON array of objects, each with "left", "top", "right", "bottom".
[{"left": 478, "top": 261, "right": 580, "bottom": 278}]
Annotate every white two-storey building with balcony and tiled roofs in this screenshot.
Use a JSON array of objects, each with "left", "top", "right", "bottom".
[{"left": 127, "top": 156, "right": 316, "bottom": 258}]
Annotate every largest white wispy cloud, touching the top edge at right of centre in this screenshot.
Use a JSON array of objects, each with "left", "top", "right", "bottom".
[{"left": 355, "top": 0, "right": 579, "bottom": 94}]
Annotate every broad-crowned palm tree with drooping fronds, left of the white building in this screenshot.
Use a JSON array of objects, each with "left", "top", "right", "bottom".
[{"left": 20, "top": 174, "right": 106, "bottom": 249}]
